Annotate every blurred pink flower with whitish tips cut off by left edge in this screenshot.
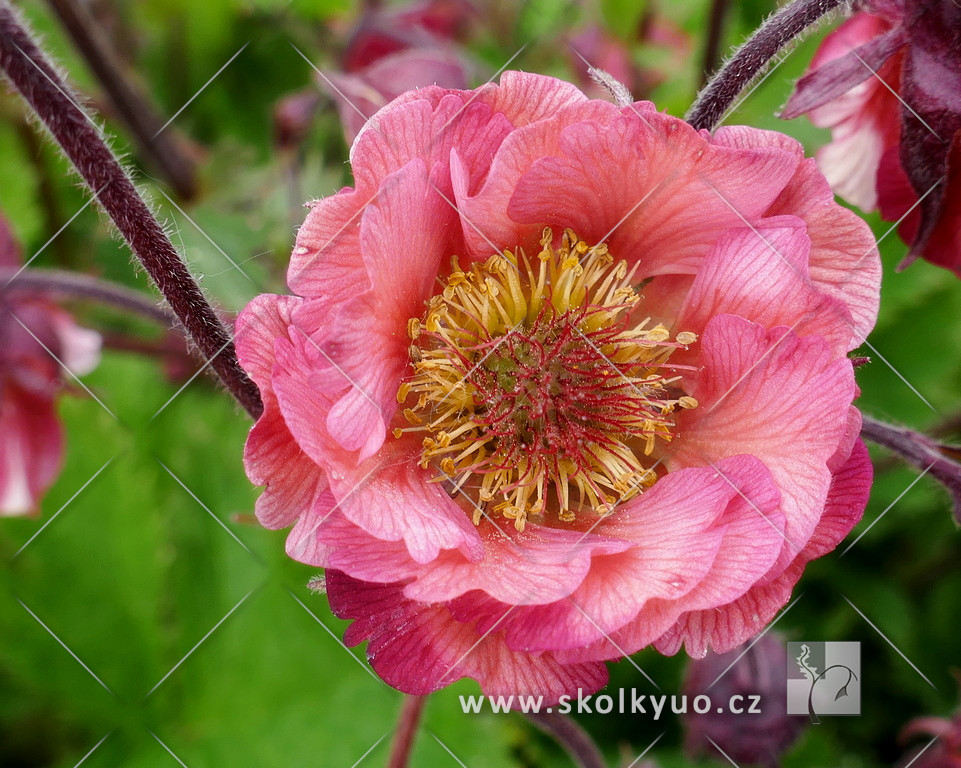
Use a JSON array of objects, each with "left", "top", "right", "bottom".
[{"left": 0, "top": 219, "right": 100, "bottom": 515}]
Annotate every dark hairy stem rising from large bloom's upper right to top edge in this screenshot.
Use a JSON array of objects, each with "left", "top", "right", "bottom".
[{"left": 686, "top": 0, "right": 849, "bottom": 131}]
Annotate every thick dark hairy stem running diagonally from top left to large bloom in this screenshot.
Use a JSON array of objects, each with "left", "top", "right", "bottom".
[{"left": 0, "top": 0, "right": 263, "bottom": 418}]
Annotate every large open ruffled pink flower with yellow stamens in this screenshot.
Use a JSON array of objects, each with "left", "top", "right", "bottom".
[{"left": 237, "top": 72, "right": 879, "bottom": 701}]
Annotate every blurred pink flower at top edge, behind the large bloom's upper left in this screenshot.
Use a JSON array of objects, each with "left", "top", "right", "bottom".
[{"left": 317, "top": 0, "right": 474, "bottom": 144}]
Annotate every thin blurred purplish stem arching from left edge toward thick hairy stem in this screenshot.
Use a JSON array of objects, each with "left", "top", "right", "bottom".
[{"left": 0, "top": 268, "right": 177, "bottom": 328}]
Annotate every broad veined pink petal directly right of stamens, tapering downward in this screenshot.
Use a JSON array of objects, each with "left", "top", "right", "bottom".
[{"left": 666, "top": 315, "right": 855, "bottom": 566}]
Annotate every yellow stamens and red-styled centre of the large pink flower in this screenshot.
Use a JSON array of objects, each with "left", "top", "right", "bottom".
[{"left": 394, "top": 229, "right": 697, "bottom": 530}]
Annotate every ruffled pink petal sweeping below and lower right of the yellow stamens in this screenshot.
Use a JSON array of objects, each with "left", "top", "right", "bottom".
[{"left": 451, "top": 456, "right": 783, "bottom": 661}]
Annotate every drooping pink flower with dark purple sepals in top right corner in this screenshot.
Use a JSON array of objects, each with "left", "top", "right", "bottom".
[{"left": 782, "top": 0, "right": 961, "bottom": 276}]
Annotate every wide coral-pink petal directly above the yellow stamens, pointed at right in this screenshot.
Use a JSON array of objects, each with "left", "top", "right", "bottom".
[{"left": 458, "top": 102, "right": 797, "bottom": 276}]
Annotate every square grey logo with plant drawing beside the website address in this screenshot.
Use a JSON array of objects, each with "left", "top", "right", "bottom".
[{"left": 787, "top": 642, "right": 861, "bottom": 725}]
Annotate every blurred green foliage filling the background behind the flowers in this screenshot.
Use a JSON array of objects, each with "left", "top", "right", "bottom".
[{"left": 0, "top": 0, "right": 961, "bottom": 768}]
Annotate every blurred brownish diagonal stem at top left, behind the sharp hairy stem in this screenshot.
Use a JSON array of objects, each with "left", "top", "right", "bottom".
[{"left": 47, "top": 0, "right": 197, "bottom": 200}]
